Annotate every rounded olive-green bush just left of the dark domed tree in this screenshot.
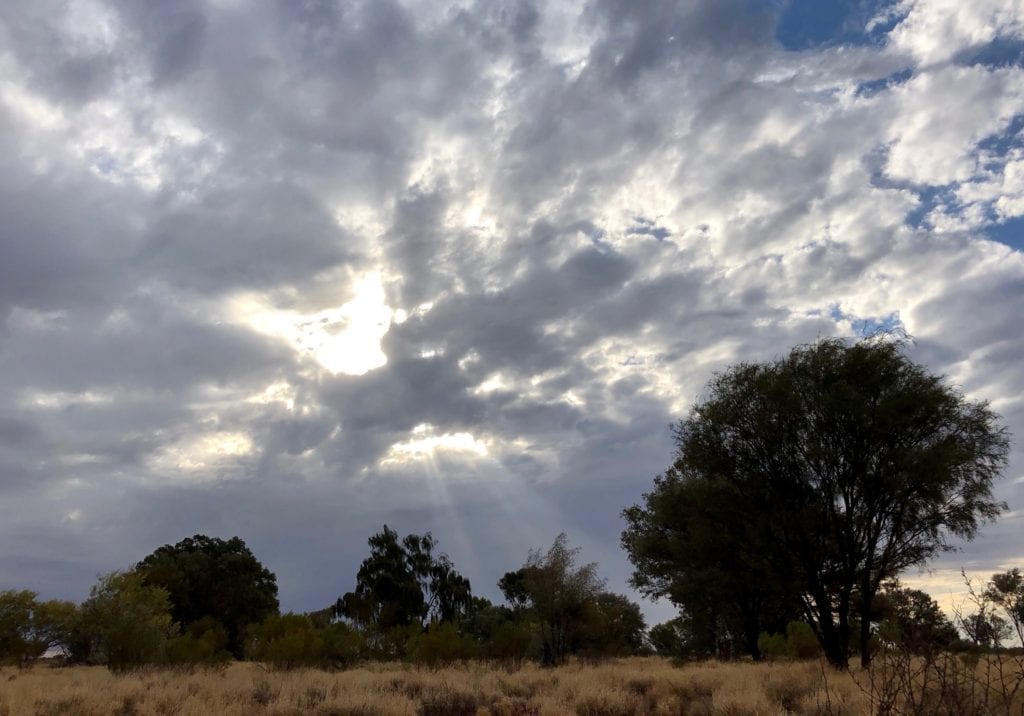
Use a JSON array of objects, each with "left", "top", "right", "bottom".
[{"left": 79, "top": 572, "right": 177, "bottom": 671}]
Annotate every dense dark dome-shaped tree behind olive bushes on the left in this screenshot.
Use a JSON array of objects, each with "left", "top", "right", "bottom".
[{"left": 135, "top": 535, "right": 278, "bottom": 658}]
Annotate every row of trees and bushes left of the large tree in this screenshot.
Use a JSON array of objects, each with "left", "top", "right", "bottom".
[{"left": 0, "top": 525, "right": 649, "bottom": 671}]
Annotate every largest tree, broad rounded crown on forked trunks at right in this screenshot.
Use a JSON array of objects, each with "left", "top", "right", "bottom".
[{"left": 628, "top": 337, "right": 1009, "bottom": 668}]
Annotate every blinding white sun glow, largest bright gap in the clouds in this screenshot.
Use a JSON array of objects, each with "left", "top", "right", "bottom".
[{"left": 227, "top": 271, "right": 395, "bottom": 375}]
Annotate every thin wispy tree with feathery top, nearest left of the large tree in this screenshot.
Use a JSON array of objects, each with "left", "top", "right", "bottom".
[{"left": 499, "top": 533, "right": 604, "bottom": 666}]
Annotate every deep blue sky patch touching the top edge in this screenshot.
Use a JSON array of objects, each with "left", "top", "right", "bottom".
[{"left": 775, "top": 0, "right": 900, "bottom": 51}]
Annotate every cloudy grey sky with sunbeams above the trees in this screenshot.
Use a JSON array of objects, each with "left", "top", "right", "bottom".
[{"left": 0, "top": 0, "right": 1024, "bottom": 622}]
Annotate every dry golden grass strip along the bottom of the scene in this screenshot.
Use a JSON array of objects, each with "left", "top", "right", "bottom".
[{"left": 0, "top": 658, "right": 1016, "bottom": 716}]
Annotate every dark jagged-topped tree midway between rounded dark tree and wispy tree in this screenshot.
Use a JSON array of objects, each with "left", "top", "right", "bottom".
[{"left": 334, "top": 524, "right": 472, "bottom": 631}]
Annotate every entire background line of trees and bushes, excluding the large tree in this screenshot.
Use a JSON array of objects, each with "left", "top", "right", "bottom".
[{"left": 0, "top": 525, "right": 1024, "bottom": 671}]
